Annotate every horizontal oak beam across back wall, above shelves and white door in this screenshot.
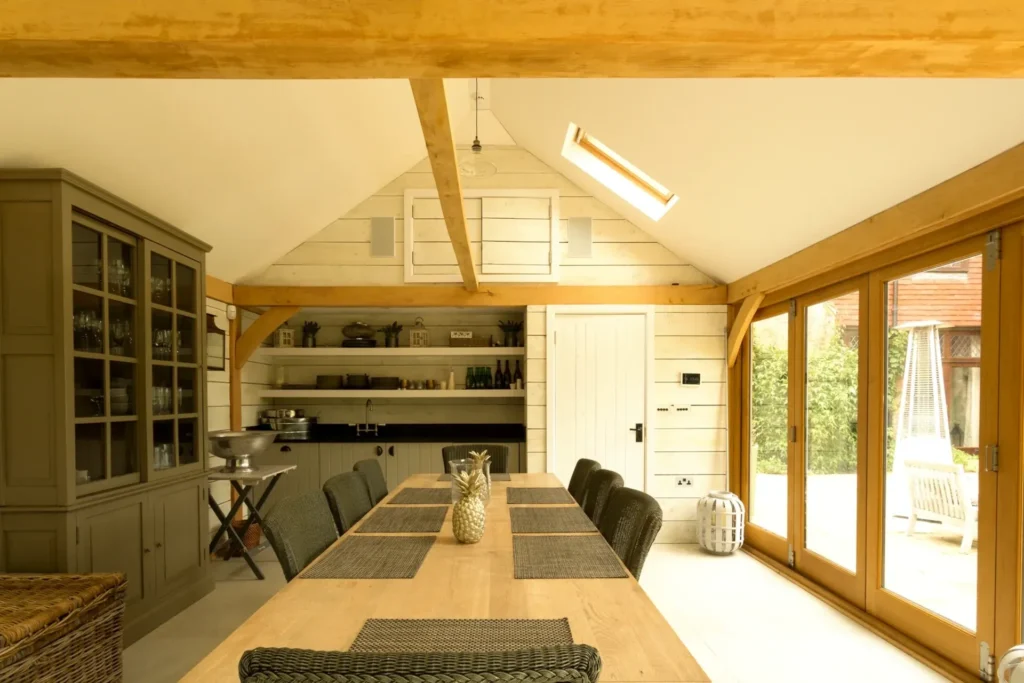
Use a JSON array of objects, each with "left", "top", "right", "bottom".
[{"left": 234, "top": 285, "right": 726, "bottom": 307}]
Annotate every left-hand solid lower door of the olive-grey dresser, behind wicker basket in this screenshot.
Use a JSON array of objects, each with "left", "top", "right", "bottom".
[{"left": 78, "top": 495, "right": 154, "bottom": 621}]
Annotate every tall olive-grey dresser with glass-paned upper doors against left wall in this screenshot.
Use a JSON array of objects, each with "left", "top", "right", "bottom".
[{"left": 0, "top": 170, "right": 212, "bottom": 642}]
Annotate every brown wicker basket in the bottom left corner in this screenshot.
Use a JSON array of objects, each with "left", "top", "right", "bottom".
[{"left": 0, "top": 573, "right": 127, "bottom": 683}]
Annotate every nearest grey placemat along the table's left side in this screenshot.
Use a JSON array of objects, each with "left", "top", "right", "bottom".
[{"left": 299, "top": 536, "right": 434, "bottom": 579}]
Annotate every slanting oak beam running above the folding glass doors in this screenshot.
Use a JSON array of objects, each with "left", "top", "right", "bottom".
[{"left": 729, "top": 143, "right": 1024, "bottom": 303}]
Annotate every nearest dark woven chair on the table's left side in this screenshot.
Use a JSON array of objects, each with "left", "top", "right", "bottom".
[{"left": 263, "top": 490, "right": 338, "bottom": 581}]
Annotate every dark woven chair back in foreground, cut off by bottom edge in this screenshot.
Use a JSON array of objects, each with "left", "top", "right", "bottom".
[{"left": 239, "top": 645, "right": 601, "bottom": 683}]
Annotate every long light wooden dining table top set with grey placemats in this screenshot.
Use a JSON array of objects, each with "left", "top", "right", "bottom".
[{"left": 182, "top": 473, "right": 710, "bottom": 683}]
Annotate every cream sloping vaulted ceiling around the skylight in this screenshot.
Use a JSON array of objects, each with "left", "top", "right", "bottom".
[{"left": 0, "top": 79, "right": 1024, "bottom": 282}]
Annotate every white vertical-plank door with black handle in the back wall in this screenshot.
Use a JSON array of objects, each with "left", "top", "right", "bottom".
[{"left": 549, "top": 313, "right": 647, "bottom": 490}]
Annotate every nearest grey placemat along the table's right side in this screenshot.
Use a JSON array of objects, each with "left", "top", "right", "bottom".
[{"left": 512, "top": 536, "right": 629, "bottom": 579}]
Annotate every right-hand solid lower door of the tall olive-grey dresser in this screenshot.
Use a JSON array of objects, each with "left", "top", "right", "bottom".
[{"left": 150, "top": 478, "right": 207, "bottom": 595}]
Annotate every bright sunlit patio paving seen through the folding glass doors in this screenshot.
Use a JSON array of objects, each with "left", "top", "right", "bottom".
[{"left": 752, "top": 474, "right": 978, "bottom": 631}]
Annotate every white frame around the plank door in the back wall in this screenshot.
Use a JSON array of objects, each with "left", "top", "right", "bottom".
[{"left": 545, "top": 305, "right": 655, "bottom": 492}]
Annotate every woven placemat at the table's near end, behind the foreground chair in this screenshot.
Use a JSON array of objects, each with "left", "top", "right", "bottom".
[{"left": 349, "top": 618, "right": 572, "bottom": 653}]
